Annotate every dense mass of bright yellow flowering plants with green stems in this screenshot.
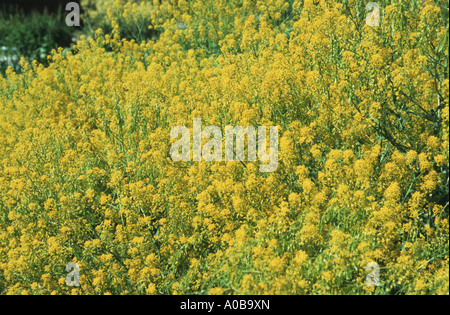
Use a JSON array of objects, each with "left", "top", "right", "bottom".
[{"left": 0, "top": 0, "right": 449, "bottom": 295}]
